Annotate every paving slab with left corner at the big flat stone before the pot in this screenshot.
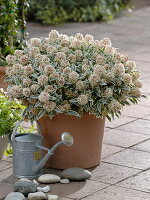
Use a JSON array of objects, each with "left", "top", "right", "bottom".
[{"left": 91, "top": 163, "right": 141, "bottom": 184}]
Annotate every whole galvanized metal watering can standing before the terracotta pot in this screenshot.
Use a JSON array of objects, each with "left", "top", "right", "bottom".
[{"left": 11, "top": 121, "right": 73, "bottom": 179}]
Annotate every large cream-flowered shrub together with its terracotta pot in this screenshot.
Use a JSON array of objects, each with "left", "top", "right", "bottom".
[{"left": 6, "top": 30, "right": 142, "bottom": 169}]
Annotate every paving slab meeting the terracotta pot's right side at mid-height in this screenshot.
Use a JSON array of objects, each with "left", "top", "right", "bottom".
[{"left": 104, "top": 129, "right": 150, "bottom": 147}]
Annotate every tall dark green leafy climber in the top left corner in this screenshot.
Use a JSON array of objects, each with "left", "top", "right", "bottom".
[{"left": 0, "top": 0, "right": 28, "bottom": 65}]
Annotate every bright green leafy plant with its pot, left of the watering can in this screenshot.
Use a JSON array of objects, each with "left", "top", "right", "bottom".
[{"left": 0, "top": 89, "right": 24, "bottom": 159}]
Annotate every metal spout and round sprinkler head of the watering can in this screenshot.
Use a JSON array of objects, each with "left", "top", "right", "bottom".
[{"left": 34, "top": 132, "right": 73, "bottom": 173}]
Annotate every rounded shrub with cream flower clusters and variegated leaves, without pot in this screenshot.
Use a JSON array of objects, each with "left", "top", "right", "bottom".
[{"left": 6, "top": 30, "right": 142, "bottom": 120}]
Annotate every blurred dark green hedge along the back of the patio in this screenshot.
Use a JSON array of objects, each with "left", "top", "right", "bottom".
[{"left": 29, "top": 0, "right": 129, "bottom": 24}]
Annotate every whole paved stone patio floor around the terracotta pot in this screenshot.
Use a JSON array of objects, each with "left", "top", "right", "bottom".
[{"left": 0, "top": 1, "right": 150, "bottom": 200}]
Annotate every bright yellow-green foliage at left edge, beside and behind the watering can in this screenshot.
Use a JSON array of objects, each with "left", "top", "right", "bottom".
[{"left": 0, "top": 88, "right": 36, "bottom": 156}]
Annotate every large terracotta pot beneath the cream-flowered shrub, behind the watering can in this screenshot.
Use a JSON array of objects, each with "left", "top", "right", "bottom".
[{"left": 39, "top": 113, "right": 105, "bottom": 169}]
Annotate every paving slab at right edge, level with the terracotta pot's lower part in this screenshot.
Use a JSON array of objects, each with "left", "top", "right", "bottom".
[{"left": 103, "top": 149, "right": 150, "bottom": 170}]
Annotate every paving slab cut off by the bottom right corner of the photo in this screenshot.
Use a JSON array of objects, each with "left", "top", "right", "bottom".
[{"left": 83, "top": 186, "right": 150, "bottom": 200}]
